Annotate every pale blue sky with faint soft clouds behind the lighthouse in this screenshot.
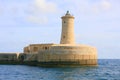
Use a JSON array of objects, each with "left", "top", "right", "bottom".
[{"left": 0, "top": 0, "right": 120, "bottom": 59}]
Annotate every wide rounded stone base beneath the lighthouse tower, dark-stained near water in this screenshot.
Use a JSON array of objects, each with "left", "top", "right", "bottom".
[{"left": 38, "top": 44, "right": 97, "bottom": 66}]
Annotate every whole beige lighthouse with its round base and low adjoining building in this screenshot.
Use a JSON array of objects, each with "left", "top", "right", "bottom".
[{"left": 24, "top": 11, "right": 97, "bottom": 67}]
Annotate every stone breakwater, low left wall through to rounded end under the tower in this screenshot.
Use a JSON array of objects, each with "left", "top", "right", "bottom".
[{"left": 0, "top": 44, "right": 97, "bottom": 66}]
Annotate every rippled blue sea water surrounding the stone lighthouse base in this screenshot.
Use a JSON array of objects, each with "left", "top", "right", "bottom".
[{"left": 0, "top": 59, "right": 120, "bottom": 80}]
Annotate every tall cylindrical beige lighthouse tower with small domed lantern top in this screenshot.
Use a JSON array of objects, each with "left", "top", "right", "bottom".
[{"left": 60, "top": 11, "right": 75, "bottom": 44}]
